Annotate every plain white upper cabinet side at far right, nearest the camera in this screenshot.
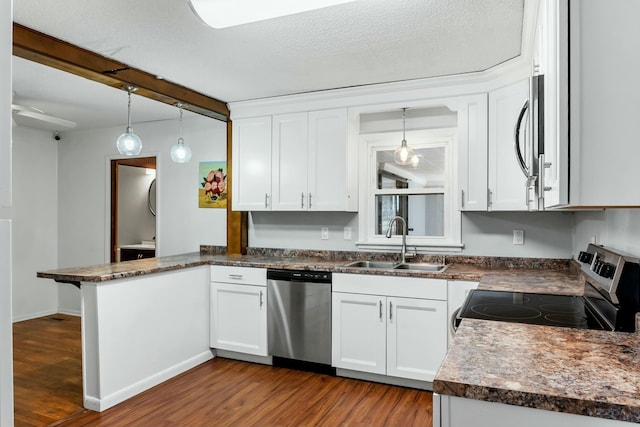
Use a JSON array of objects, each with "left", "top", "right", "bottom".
[{"left": 569, "top": 0, "right": 640, "bottom": 206}]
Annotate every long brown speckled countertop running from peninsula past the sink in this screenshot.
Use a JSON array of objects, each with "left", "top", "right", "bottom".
[{"left": 37, "top": 249, "right": 571, "bottom": 287}]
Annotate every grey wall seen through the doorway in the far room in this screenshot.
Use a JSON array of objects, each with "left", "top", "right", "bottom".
[{"left": 118, "top": 165, "right": 156, "bottom": 246}]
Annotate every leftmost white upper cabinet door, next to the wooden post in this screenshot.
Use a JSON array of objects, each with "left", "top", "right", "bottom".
[{"left": 231, "top": 116, "right": 271, "bottom": 211}]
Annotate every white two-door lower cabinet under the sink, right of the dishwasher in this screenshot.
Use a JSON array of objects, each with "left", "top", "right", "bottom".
[{"left": 332, "top": 274, "right": 447, "bottom": 381}]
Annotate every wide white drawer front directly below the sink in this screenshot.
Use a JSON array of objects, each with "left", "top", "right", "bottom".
[{"left": 332, "top": 273, "right": 447, "bottom": 301}]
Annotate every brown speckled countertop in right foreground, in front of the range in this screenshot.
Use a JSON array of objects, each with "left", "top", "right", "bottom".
[{"left": 433, "top": 319, "right": 640, "bottom": 423}]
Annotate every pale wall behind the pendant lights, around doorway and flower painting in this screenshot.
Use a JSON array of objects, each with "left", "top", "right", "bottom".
[{"left": 58, "top": 116, "right": 226, "bottom": 313}]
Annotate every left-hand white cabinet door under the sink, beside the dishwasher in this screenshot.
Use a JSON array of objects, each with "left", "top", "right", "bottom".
[{"left": 331, "top": 292, "right": 386, "bottom": 375}]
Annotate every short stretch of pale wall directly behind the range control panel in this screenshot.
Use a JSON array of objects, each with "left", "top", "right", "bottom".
[{"left": 573, "top": 209, "right": 640, "bottom": 256}]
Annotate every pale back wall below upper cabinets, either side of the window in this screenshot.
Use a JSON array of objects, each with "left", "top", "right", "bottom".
[{"left": 249, "top": 212, "right": 573, "bottom": 258}]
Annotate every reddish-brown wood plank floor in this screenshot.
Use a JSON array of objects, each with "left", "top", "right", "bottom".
[{"left": 14, "top": 315, "right": 432, "bottom": 427}]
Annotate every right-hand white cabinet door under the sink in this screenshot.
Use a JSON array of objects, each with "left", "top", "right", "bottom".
[{"left": 387, "top": 298, "right": 447, "bottom": 381}]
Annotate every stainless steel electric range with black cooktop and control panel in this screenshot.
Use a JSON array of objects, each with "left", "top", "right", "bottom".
[{"left": 455, "top": 244, "right": 640, "bottom": 332}]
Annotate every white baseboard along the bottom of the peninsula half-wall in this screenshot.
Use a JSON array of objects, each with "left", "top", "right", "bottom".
[{"left": 84, "top": 350, "right": 214, "bottom": 412}]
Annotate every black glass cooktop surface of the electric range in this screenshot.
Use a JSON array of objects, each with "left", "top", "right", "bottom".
[{"left": 456, "top": 289, "right": 603, "bottom": 329}]
